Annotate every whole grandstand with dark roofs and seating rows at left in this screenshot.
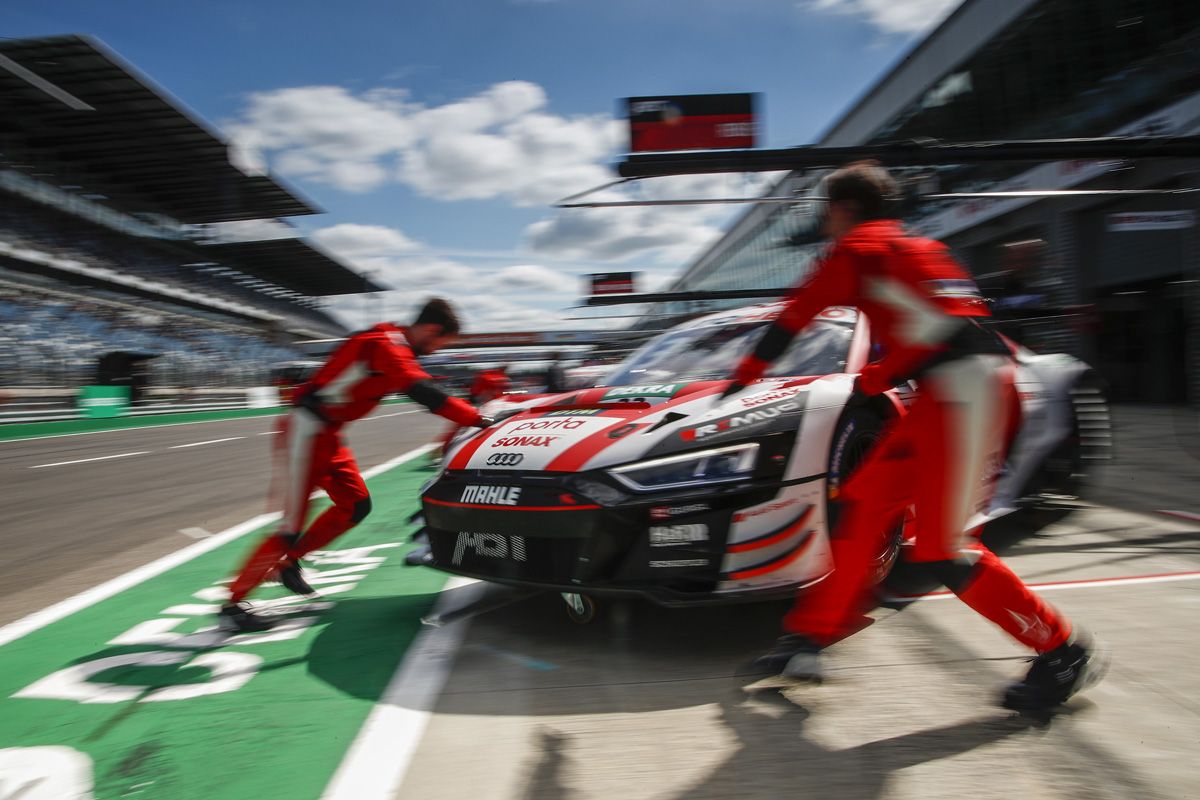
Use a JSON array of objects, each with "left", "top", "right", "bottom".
[{"left": 0, "top": 36, "right": 382, "bottom": 407}]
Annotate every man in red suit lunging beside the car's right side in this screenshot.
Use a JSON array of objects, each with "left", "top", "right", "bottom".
[{"left": 726, "top": 162, "right": 1103, "bottom": 710}]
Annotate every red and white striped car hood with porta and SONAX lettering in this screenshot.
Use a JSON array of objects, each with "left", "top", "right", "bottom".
[{"left": 444, "top": 375, "right": 852, "bottom": 473}]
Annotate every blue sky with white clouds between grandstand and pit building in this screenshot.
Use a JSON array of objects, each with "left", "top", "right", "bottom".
[{"left": 0, "top": 0, "right": 958, "bottom": 330}]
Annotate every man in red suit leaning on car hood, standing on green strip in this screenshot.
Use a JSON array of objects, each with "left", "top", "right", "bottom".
[{"left": 220, "top": 299, "right": 490, "bottom": 631}]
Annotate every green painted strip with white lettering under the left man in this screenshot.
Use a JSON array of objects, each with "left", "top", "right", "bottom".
[{"left": 0, "top": 457, "right": 445, "bottom": 800}]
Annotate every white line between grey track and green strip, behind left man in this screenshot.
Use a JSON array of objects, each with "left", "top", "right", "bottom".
[{"left": 0, "top": 445, "right": 434, "bottom": 646}]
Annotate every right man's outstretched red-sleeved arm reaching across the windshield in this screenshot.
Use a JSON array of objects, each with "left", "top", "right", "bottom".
[{"left": 733, "top": 250, "right": 858, "bottom": 386}]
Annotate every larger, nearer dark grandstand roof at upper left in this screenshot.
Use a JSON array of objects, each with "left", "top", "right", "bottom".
[{"left": 0, "top": 36, "right": 318, "bottom": 223}]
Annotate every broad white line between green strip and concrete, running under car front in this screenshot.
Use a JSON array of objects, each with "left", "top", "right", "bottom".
[{"left": 320, "top": 578, "right": 485, "bottom": 800}]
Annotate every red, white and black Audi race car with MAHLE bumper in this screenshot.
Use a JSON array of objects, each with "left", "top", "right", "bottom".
[{"left": 421, "top": 303, "right": 1108, "bottom": 621}]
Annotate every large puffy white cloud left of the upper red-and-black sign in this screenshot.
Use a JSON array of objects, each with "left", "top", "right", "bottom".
[{"left": 226, "top": 80, "right": 622, "bottom": 205}]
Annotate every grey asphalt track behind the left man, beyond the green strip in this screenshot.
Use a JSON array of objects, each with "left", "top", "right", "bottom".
[{"left": 0, "top": 405, "right": 449, "bottom": 625}]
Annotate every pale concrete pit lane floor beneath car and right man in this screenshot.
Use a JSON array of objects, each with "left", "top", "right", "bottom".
[{"left": 396, "top": 506, "right": 1200, "bottom": 800}]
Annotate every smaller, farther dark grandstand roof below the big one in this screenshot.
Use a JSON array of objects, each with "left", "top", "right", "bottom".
[{"left": 202, "top": 239, "right": 388, "bottom": 296}]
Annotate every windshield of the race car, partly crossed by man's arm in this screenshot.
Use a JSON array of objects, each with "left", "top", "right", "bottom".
[{"left": 604, "top": 320, "right": 854, "bottom": 386}]
